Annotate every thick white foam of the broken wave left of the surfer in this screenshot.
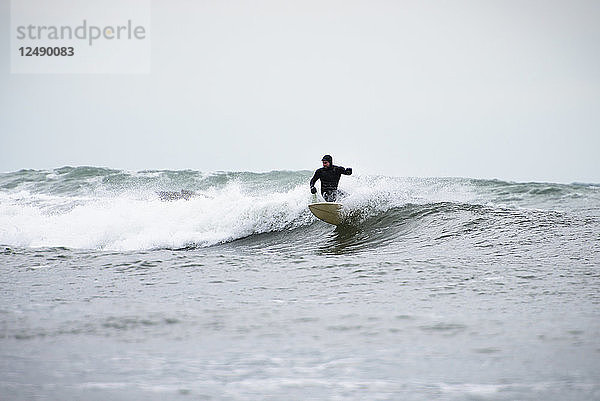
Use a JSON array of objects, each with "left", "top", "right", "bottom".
[{"left": 0, "top": 182, "right": 312, "bottom": 250}]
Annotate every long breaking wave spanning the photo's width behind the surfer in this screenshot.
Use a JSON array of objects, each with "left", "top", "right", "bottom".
[{"left": 0, "top": 167, "right": 600, "bottom": 251}]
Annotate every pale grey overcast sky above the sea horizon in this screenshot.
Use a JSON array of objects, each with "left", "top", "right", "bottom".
[{"left": 0, "top": 0, "right": 600, "bottom": 183}]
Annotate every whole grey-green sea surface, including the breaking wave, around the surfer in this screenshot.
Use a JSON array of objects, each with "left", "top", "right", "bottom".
[{"left": 0, "top": 167, "right": 600, "bottom": 400}]
